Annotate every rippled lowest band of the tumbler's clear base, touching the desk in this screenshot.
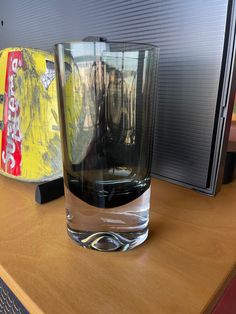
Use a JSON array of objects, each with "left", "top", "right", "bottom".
[{"left": 67, "top": 226, "right": 148, "bottom": 252}]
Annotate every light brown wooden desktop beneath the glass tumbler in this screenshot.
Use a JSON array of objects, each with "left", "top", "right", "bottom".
[{"left": 0, "top": 177, "right": 236, "bottom": 314}]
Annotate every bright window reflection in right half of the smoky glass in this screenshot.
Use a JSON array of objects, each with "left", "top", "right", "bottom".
[{"left": 103, "top": 51, "right": 138, "bottom": 145}]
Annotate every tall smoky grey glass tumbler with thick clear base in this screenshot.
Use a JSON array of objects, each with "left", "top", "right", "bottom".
[{"left": 55, "top": 41, "right": 158, "bottom": 251}]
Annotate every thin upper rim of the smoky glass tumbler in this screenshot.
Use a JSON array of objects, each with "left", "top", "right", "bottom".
[{"left": 54, "top": 40, "right": 160, "bottom": 49}]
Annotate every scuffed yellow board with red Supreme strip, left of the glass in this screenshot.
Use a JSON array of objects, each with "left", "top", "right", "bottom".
[{"left": 0, "top": 48, "right": 62, "bottom": 182}]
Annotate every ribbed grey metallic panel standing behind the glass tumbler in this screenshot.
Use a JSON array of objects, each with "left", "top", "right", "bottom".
[{"left": 0, "top": 0, "right": 228, "bottom": 188}]
